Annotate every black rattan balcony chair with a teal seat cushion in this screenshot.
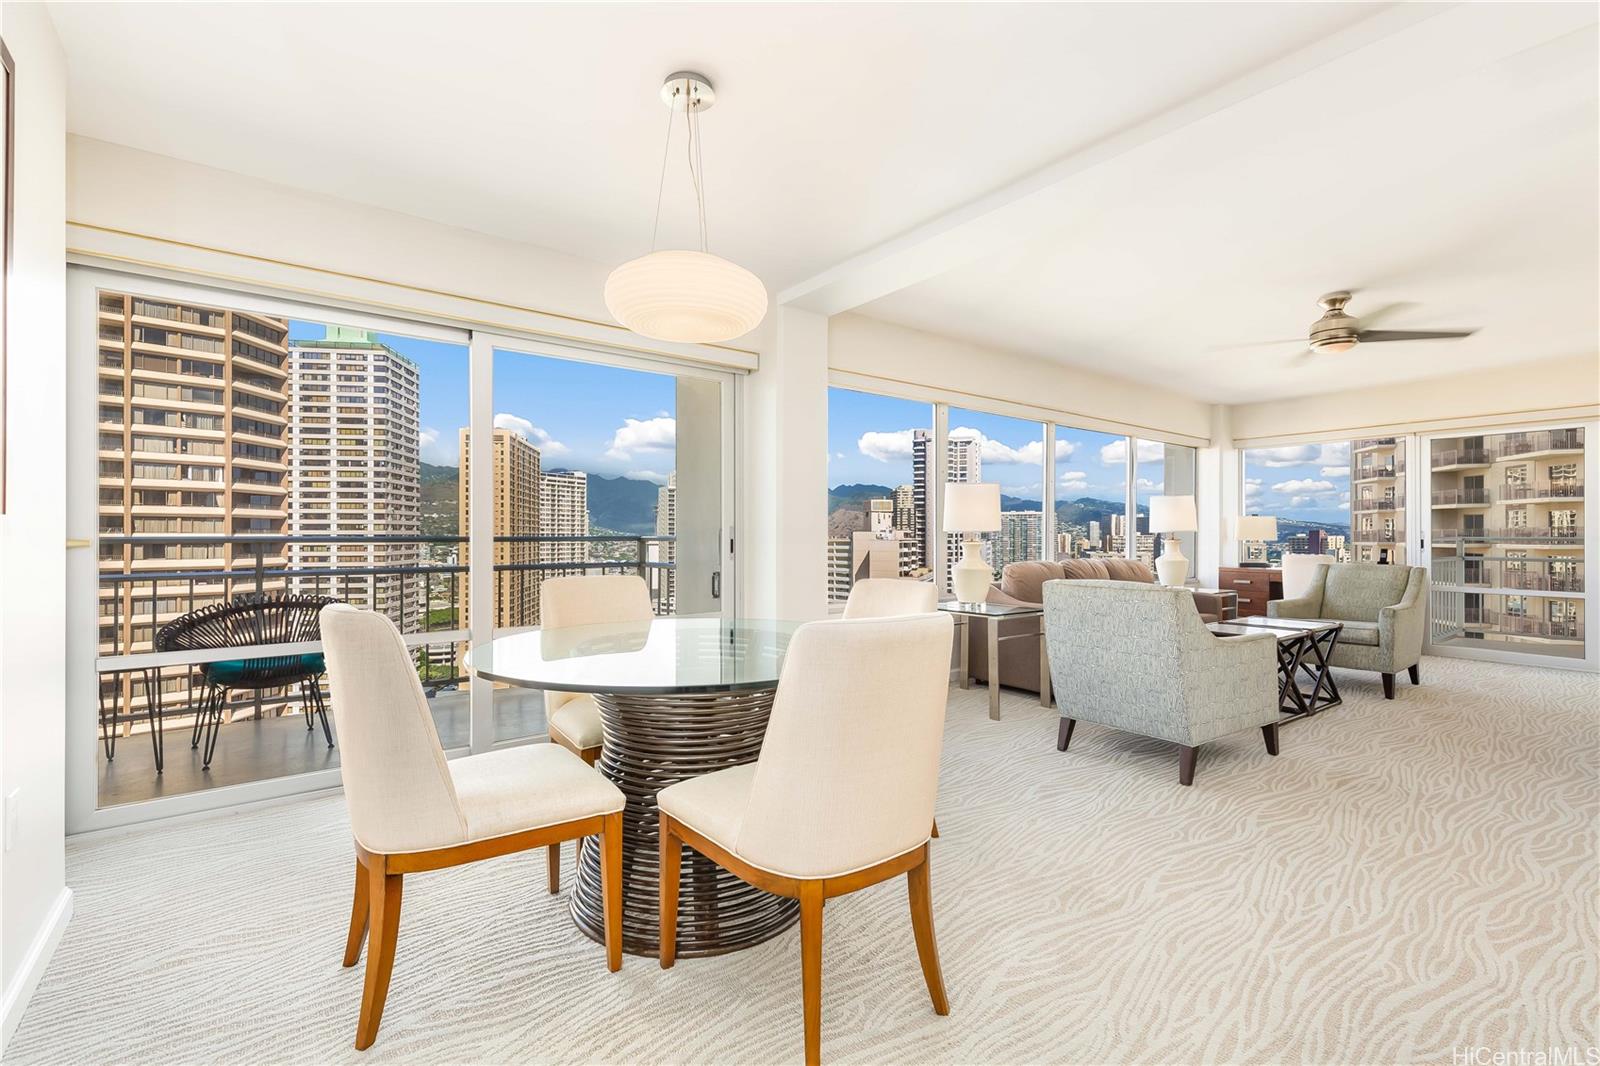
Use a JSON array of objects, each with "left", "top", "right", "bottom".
[{"left": 155, "top": 595, "right": 339, "bottom": 770}]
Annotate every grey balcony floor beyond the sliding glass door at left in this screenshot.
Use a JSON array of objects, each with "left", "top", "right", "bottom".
[{"left": 96, "top": 688, "right": 544, "bottom": 807}]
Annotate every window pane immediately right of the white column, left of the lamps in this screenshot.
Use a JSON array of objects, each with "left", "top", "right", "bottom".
[{"left": 827, "top": 389, "right": 933, "bottom": 603}]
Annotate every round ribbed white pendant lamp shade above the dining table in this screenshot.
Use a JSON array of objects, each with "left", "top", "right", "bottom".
[{"left": 605, "top": 251, "right": 766, "bottom": 344}]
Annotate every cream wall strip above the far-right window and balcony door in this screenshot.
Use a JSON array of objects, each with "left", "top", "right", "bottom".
[{"left": 1229, "top": 355, "right": 1600, "bottom": 445}]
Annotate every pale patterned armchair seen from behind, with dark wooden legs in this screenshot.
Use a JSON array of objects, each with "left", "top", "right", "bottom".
[{"left": 1045, "top": 581, "right": 1278, "bottom": 784}]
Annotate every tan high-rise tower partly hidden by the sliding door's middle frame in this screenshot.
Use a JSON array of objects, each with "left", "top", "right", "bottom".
[{"left": 459, "top": 429, "right": 544, "bottom": 629}]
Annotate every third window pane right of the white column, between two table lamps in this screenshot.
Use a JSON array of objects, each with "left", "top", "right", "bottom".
[{"left": 1056, "top": 426, "right": 1128, "bottom": 559}]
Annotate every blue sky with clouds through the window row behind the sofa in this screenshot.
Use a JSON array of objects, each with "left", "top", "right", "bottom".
[{"left": 827, "top": 389, "right": 1139, "bottom": 499}]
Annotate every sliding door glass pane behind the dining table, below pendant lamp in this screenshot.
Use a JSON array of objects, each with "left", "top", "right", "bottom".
[{"left": 486, "top": 349, "right": 723, "bottom": 739}]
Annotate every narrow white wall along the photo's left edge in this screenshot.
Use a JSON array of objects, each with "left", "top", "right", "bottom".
[{"left": 0, "top": 3, "right": 72, "bottom": 1045}]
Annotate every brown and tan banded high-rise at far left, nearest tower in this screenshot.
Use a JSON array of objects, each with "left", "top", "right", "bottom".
[{"left": 96, "top": 291, "right": 288, "bottom": 659}]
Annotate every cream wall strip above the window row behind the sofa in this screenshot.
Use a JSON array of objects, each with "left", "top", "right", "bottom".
[{"left": 827, "top": 314, "right": 1211, "bottom": 443}]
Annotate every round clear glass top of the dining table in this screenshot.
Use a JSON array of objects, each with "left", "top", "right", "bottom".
[{"left": 467, "top": 618, "right": 802, "bottom": 695}]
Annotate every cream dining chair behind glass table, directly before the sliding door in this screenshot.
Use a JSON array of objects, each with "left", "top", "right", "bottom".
[{"left": 539, "top": 573, "right": 656, "bottom": 895}]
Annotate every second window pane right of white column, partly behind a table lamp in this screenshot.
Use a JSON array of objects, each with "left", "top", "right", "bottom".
[{"left": 944, "top": 407, "right": 1045, "bottom": 587}]
